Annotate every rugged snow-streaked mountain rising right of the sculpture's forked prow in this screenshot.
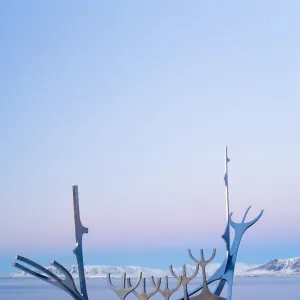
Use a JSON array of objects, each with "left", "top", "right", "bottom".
[{"left": 247, "top": 257, "right": 300, "bottom": 276}]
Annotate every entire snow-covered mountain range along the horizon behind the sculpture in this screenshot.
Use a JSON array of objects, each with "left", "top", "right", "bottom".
[{"left": 13, "top": 257, "right": 300, "bottom": 278}]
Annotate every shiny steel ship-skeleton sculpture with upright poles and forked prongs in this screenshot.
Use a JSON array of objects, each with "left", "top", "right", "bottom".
[{"left": 13, "top": 147, "right": 263, "bottom": 300}]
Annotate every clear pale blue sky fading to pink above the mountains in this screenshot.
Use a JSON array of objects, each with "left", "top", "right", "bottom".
[{"left": 0, "top": 0, "right": 300, "bottom": 276}]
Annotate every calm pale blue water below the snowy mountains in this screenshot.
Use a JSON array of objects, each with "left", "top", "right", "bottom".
[{"left": 0, "top": 277, "right": 300, "bottom": 300}]
